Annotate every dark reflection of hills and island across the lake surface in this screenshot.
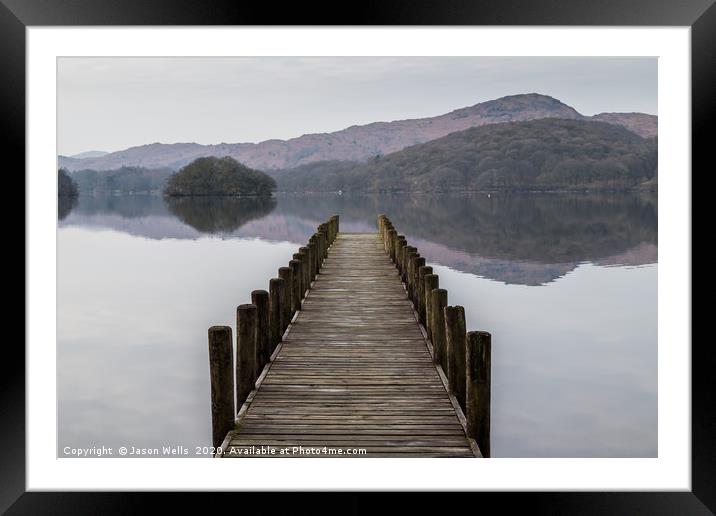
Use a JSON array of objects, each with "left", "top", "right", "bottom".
[{"left": 62, "top": 194, "right": 658, "bottom": 285}]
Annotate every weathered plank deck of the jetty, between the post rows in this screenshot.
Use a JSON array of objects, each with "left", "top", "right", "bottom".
[{"left": 218, "top": 233, "right": 474, "bottom": 457}]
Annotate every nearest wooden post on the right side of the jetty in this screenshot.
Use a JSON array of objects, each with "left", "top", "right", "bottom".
[{"left": 465, "top": 331, "right": 492, "bottom": 457}]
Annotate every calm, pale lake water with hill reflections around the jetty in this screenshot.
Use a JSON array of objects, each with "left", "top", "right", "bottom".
[{"left": 57, "top": 194, "right": 657, "bottom": 457}]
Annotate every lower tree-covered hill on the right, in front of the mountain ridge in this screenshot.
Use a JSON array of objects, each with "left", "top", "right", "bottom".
[{"left": 272, "top": 118, "right": 657, "bottom": 192}]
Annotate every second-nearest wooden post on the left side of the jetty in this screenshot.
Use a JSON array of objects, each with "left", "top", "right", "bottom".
[{"left": 236, "top": 305, "right": 256, "bottom": 407}]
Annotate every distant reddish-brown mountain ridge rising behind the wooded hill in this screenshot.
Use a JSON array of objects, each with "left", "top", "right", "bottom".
[{"left": 59, "top": 93, "right": 656, "bottom": 170}]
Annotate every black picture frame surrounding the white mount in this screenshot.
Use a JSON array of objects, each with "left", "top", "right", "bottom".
[{"left": 5, "top": 0, "right": 716, "bottom": 515}]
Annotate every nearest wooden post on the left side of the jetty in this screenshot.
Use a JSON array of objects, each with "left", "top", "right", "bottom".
[{"left": 209, "top": 326, "right": 236, "bottom": 448}]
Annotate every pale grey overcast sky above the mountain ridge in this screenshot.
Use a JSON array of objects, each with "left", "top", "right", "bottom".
[{"left": 57, "top": 57, "right": 657, "bottom": 155}]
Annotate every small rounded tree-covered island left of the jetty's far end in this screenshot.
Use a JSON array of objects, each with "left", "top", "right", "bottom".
[{"left": 164, "top": 156, "right": 276, "bottom": 197}]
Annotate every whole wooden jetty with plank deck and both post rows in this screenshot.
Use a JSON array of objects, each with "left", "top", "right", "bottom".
[{"left": 204, "top": 215, "right": 491, "bottom": 458}]
